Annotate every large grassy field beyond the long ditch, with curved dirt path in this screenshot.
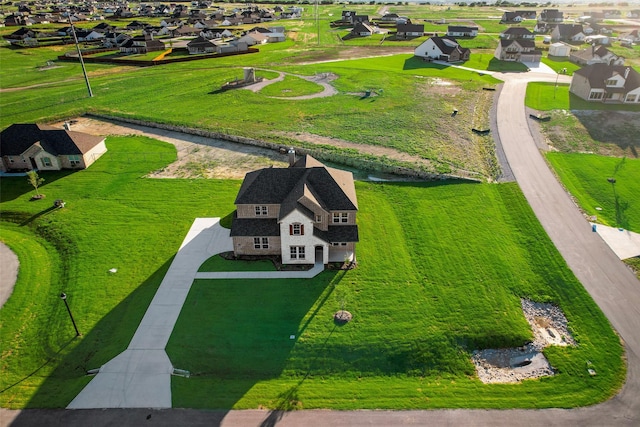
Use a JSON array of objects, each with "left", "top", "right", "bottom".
[{"left": 0, "top": 43, "right": 497, "bottom": 177}]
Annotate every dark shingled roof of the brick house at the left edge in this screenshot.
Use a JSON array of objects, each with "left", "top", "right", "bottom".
[{"left": 0, "top": 123, "right": 104, "bottom": 156}]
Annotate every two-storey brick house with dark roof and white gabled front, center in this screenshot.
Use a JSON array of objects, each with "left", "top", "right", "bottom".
[{"left": 231, "top": 154, "right": 358, "bottom": 264}]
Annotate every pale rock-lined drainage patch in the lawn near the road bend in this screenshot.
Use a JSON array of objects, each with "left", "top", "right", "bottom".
[{"left": 471, "top": 299, "right": 575, "bottom": 384}]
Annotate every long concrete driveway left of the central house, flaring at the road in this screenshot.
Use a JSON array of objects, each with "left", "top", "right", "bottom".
[{"left": 67, "top": 218, "right": 233, "bottom": 409}]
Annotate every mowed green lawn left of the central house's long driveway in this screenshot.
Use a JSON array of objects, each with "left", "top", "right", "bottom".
[{"left": 0, "top": 137, "right": 239, "bottom": 408}]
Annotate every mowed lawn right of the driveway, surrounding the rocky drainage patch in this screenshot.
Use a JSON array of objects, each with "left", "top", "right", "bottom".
[{"left": 167, "top": 183, "right": 624, "bottom": 410}]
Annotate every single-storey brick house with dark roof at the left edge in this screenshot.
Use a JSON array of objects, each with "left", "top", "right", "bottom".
[{"left": 0, "top": 123, "right": 107, "bottom": 172}]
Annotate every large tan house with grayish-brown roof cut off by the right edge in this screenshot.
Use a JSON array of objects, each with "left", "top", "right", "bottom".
[{"left": 569, "top": 64, "right": 640, "bottom": 104}]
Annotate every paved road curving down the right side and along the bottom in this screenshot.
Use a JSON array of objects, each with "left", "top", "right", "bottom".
[{"left": 0, "top": 73, "right": 640, "bottom": 427}]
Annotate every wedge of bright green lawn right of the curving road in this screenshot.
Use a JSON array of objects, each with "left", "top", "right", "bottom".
[{"left": 547, "top": 153, "right": 640, "bottom": 233}]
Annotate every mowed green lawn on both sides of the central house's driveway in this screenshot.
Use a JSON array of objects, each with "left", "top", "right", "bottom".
[{"left": 0, "top": 137, "right": 624, "bottom": 409}]
